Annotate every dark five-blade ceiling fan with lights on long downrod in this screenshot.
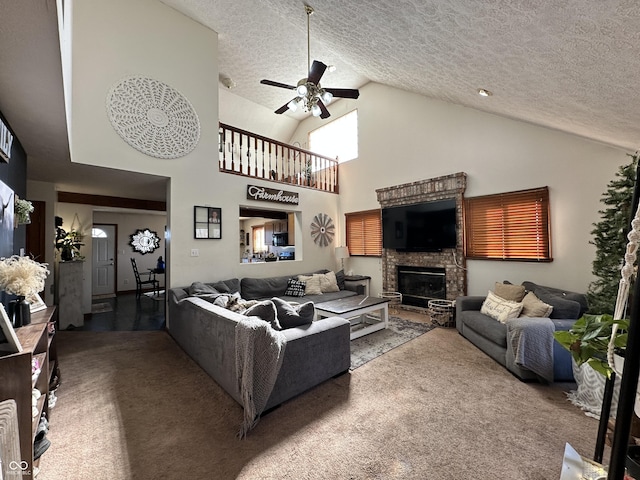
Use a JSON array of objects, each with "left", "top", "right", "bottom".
[{"left": 260, "top": 5, "right": 360, "bottom": 118}]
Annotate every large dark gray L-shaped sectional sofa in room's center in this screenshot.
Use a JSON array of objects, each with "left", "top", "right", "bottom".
[{"left": 168, "top": 270, "right": 356, "bottom": 410}]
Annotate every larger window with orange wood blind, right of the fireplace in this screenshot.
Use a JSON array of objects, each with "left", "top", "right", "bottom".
[{"left": 465, "top": 187, "right": 553, "bottom": 262}]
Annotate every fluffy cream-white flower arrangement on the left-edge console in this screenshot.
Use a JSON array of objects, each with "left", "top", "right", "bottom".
[{"left": 0, "top": 255, "right": 49, "bottom": 297}]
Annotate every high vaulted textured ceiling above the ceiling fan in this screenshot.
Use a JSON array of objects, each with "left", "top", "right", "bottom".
[{"left": 163, "top": 0, "right": 640, "bottom": 150}]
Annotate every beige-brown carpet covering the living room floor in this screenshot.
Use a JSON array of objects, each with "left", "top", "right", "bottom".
[{"left": 38, "top": 329, "right": 608, "bottom": 480}]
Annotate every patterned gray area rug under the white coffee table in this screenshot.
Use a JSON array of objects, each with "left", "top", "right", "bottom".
[{"left": 350, "top": 317, "right": 435, "bottom": 370}]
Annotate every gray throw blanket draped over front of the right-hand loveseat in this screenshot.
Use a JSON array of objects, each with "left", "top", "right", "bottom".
[{"left": 507, "top": 317, "right": 555, "bottom": 382}]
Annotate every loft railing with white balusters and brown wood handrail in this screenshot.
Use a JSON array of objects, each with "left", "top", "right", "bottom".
[{"left": 218, "top": 123, "right": 338, "bottom": 193}]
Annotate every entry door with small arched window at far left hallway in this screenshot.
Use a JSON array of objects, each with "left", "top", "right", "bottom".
[{"left": 91, "top": 224, "right": 116, "bottom": 295}]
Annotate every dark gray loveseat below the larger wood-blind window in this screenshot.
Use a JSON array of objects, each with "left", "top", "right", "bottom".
[{"left": 456, "top": 282, "right": 588, "bottom": 382}]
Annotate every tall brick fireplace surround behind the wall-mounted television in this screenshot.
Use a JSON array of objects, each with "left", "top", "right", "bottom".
[{"left": 376, "top": 172, "right": 467, "bottom": 307}]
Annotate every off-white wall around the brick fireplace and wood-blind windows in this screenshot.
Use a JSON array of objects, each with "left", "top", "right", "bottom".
[{"left": 291, "top": 83, "right": 629, "bottom": 295}]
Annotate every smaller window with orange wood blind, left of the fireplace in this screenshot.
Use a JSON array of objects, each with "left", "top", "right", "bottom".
[{"left": 345, "top": 210, "right": 382, "bottom": 257}]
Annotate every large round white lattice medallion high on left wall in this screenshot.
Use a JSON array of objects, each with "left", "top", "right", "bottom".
[{"left": 107, "top": 76, "right": 200, "bottom": 158}]
